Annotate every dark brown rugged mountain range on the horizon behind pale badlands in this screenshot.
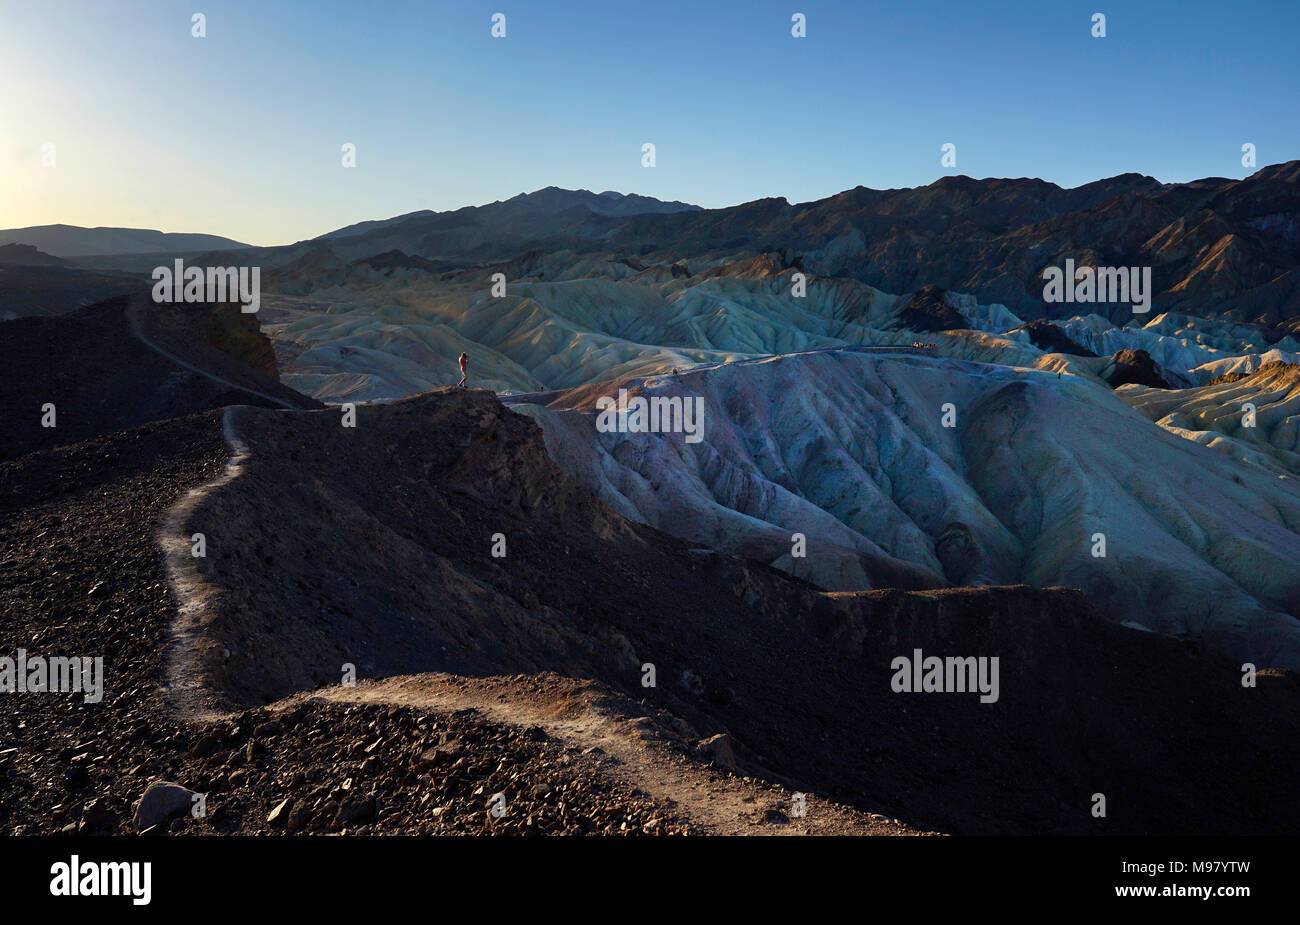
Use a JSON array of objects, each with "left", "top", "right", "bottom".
[{"left": 223, "top": 167, "right": 1300, "bottom": 336}]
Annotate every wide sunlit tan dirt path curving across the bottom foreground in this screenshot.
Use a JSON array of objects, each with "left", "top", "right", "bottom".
[{"left": 297, "top": 674, "right": 926, "bottom": 835}]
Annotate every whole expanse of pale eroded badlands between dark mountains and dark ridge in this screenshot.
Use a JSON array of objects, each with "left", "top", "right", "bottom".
[{"left": 250, "top": 241, "right": 1300, "bottom": 668}]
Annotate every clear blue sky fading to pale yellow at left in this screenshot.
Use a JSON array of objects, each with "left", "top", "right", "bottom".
[{"left": 0, "top": 0, "right": 1300, "bottom": 244}]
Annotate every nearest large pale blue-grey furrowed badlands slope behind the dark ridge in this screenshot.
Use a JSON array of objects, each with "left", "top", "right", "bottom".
[{"left": 508, "top": 349, "right": 1300, "bottom": 666}]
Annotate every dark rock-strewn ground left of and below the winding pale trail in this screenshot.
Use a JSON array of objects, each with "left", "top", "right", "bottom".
[{"left": 0, "top": 413, "right": 690, "bottom": 834}]
